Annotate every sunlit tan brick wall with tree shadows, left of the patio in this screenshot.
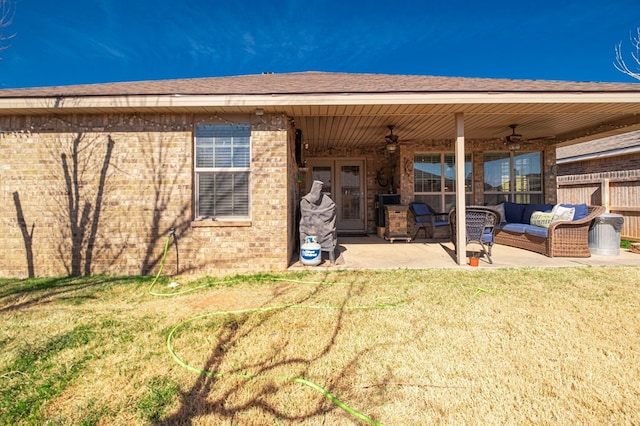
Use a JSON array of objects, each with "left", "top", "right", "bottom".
[{"left": 0, "top": 114, "right": 293, "bottom": 277}]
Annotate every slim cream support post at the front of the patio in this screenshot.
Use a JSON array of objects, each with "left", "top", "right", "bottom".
[{"left": 455, "top": 112, "right": 467, "bottom": 265}]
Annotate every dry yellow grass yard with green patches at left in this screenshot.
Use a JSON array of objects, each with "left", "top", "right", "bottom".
[{"left": 0, "top": 267, "right": 640, "bottom": 425}]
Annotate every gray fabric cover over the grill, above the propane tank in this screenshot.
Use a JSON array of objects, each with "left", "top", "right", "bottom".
[{"left": 300, "top": 180, "right": 337, "bottom": 251}]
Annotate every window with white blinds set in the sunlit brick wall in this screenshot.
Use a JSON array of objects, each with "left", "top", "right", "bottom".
[{"left": 194, "top": 124, "right": 251, "bottom": 219}]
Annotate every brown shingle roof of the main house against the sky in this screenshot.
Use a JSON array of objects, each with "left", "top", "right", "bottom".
[{"left": 0, "top": 72, "right": 640, "bottom": 98}]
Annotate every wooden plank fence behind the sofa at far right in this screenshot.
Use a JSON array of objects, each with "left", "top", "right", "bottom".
[{"left": 558, "top": 175, "right": 640, "bottom": 241}]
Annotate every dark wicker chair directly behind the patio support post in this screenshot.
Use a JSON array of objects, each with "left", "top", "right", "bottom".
[{"left": 449, "top": 206, "right": 500, "bottom": 263}]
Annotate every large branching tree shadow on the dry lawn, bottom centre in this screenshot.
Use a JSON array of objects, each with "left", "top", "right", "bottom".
[{"left": 153, "top": 285, "right": 375, "bottom": 426}]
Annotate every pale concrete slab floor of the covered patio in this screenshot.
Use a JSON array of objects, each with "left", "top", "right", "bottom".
[{"left": 289, "top": 235, "right": 640, "bottom": 270}]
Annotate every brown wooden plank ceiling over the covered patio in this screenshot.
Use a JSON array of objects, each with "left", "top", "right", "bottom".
[{"left": 286, "top": 103, "right": 640, "bottom": 150}]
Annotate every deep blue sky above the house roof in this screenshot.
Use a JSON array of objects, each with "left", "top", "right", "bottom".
[{"left": 0, "top": 0, "right": 640, "bottom": 88}]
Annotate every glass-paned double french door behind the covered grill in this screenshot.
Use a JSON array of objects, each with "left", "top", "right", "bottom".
[{"left": 307, "top": 159, "right": 367, "bottom": 232}]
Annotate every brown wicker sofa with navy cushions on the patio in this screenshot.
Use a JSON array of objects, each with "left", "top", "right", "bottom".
[{"left": 494, "top": 203, "right": 605, "bottom": 257}]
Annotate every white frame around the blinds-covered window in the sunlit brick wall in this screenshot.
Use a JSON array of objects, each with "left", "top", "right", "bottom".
[{"left": 193, "top": 123, "right": 253, "bottom": 222}]
